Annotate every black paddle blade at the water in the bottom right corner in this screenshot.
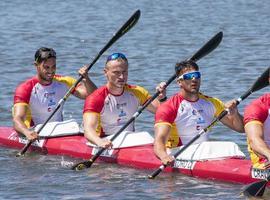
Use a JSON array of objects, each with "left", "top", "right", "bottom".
[{"left": 243, "top": 180, "right": 268, "bottom": 197}]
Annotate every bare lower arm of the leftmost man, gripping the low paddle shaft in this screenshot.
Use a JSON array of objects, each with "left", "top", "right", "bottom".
[{"left": 13, "top": 104, "right": 38, "bottom": 140}]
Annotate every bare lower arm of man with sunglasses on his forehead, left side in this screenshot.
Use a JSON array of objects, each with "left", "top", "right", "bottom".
[{"left": 83, "top": 113, "right": 111, "bottom": 148}]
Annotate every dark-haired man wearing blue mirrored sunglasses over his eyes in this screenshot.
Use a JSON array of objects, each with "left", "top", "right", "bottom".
[{"left": 154, "top": 61, "right": 244, "bottom": 165}]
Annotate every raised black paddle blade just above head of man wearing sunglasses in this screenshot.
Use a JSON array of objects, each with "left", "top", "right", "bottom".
[{"left": 188, "top": 32, "right": 223, "bottom": 62}]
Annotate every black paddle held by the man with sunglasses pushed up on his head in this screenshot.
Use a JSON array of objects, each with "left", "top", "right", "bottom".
[{"left": 71, "top": 32, "right": 223, "bottom": 171}]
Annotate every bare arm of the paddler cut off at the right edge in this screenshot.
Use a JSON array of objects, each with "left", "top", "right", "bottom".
[{"left": 245, "top": 123, "right": 270, "bottom": 161}]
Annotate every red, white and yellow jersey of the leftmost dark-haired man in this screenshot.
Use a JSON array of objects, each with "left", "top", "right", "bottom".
[{"left": 14, "top": 75, "right": 76, "bottom": 127}]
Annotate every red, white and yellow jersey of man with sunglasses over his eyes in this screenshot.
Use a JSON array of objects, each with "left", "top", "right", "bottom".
[{"left": 155, "top": 93, "right": 225, "bottom": 148}]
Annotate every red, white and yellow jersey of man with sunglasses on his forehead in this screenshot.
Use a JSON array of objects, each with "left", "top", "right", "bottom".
[{"left": 84, "top": 84, "right": 150, "bottom": 137}]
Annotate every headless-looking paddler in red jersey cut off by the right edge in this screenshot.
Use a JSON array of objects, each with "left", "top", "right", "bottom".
[{"left": 244, "top": 68, "right": 270, "bottom": 169}]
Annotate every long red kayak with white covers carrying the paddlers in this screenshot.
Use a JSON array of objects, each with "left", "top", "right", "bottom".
[{"left": 0, "top": 127, "right": 269, "bottom": 184}]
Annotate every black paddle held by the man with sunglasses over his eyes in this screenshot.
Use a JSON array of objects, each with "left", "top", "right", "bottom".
[{"left": 148, "top": 68, "right": 269, "bottom": 179}]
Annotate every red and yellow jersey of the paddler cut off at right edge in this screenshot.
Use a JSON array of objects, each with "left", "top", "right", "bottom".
[{"left": 244, "top": 93, "right": 270, "bottom": 168}]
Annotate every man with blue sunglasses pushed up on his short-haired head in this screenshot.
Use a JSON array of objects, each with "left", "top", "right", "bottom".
[{"left": 83, "top": 53, "right": 166, "bottom": 148}]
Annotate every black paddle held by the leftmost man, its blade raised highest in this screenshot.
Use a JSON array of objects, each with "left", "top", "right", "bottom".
[{"left": 16, "top": 10, "right": 141, "bottom": 156}]
